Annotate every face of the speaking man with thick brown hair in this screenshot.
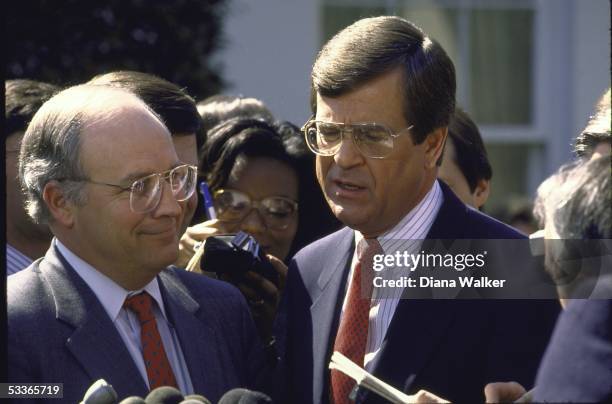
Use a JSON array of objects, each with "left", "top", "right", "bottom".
[{"left": 316, "top": 69, "right": 446, "bottom": 237}]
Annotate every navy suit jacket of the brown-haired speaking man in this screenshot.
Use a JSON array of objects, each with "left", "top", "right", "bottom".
[{"left": 276, "top": 184, "right": 560, "bottom": 403}]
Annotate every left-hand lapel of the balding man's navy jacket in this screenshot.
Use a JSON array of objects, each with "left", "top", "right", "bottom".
[{"left": 40, "top": 243, "right": 148, "bottom": 397}]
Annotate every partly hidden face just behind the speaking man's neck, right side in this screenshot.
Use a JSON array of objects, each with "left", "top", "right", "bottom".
[{"left": 438, "top": 136, "right": 490, "bottom": 209}]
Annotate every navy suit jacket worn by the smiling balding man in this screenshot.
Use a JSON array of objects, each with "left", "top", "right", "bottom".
[{"left": 7, "top": 243, "right": 265, "bottom": 403}]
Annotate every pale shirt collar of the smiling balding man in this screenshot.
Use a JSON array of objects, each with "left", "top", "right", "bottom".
[{"left": 55, "top": 239, "right": 168, "bottom": 322}]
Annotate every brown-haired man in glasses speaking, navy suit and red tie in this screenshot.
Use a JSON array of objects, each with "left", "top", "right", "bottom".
[{"left": 278, "top": 17, "right": 558, "bottom": 403}]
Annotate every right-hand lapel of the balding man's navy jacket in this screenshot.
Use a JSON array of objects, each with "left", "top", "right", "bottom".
[{"left": 158, "top": 270, "right": 218, "bottom": 392}]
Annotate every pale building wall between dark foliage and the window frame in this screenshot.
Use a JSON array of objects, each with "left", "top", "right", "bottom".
[{"left": 220, "top": 0, "right": 320, "bottom": 126}]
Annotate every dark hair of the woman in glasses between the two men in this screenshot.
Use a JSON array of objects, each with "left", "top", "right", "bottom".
[{"left": 199, "top": 118, "right": 338, "bottom": 258}]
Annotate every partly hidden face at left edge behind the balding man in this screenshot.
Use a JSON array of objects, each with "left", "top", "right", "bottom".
[{"left": 5, "top": 132, "right": 52, "bottom": 243}]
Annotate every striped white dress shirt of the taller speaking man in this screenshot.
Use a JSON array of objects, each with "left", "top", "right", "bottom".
[{"left": 342, "top": 180, "right": 444, "bottom": 371}]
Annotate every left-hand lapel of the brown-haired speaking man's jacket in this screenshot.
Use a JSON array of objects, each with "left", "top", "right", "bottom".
[{"left": 310, "top": 228, "right": 354, "bottom": 402}]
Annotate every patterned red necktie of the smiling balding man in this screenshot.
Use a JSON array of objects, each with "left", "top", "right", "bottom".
[{"left": 123, "top": 292, "right": 177, "bottom": 390}]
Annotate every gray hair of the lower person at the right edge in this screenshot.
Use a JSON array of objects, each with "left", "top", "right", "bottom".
[{"left": 534, "top": 155, "right": 612, "bottom": 297}]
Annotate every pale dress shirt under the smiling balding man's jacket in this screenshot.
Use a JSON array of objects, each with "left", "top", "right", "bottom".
[{"left": 56, "top": 240, "right": 193, "bottom": 394}]
